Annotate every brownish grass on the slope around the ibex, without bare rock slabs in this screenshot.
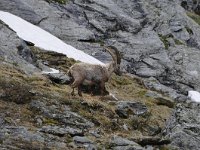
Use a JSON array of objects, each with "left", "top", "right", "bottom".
[{"left": 0, "top": 47, "right": 172, "bottom": 148}]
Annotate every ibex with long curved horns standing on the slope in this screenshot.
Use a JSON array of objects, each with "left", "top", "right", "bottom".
[{"left": 68, "top": 46, "right": 121, "bottom": 96}]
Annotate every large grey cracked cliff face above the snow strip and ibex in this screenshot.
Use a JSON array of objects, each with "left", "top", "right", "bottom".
[{"left": 0, "top": 0, "right": 200, "bottom": 99}]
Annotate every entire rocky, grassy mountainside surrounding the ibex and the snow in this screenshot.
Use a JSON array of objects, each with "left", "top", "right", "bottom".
[{"left": 0, "top": 0, "right": 200, "bottom": 149}]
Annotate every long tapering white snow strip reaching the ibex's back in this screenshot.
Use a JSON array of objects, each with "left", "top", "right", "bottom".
[{"left": 0, "top": 11, "right": 104, "bottom": 65}]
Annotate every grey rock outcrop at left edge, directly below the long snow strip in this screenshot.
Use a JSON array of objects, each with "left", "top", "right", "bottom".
[{"left": 0, "top": 21, "right": 38, "bottom": 74}]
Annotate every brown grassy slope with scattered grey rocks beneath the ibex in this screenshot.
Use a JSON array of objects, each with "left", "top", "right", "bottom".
[{"left": 0, "top": 50, "right": 174, "bottom": 149}]
